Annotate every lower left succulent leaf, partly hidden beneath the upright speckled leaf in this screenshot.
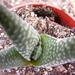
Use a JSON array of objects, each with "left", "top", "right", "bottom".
[{"left": 0, "top": 45, "right": 28, "bottom": 70}]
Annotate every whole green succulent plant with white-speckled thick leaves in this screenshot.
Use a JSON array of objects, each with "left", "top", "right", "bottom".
[{"left": 0, "top": 5, "right": 75, "bottom": 69}]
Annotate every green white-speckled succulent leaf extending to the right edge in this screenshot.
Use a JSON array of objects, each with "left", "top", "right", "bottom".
[{"left": 32, "top": 34, "right": 75, "bottom": 66}]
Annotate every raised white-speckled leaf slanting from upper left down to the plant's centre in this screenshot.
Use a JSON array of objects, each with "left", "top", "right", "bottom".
[{"left": 0, "top": 5, "right": 40, "bottom": 61}]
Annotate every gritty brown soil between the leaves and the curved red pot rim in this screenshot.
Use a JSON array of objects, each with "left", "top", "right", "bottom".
[{"left": 14, "top": 6, "right": 75, "bottom": 38}]
